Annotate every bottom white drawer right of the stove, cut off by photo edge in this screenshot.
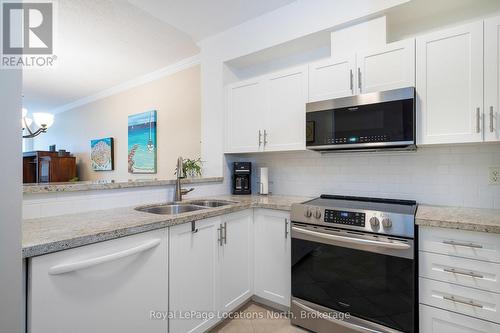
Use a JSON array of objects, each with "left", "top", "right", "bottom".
[{"left": 420, "top": 304, "right": 500, "bottom": 333}]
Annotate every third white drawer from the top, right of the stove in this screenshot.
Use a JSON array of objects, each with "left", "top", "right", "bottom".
[{"left": 419, "top": 278, "right": 500, "bottom": 323}]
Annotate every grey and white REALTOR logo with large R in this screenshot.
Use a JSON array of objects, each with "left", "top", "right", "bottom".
[{"left": 1, "top": 0, "right": 57, "bottom": 68}]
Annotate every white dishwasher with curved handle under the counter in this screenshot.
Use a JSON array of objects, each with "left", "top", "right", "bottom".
[{"left": 28, "top": 229, "right": 168, "bottom": 333}]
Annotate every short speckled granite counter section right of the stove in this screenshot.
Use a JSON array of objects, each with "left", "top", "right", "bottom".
[{"left": 416, "top": 205, "right": 500, "bottom": 234}]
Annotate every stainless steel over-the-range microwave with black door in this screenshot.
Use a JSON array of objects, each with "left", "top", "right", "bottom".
[{"left": 306, "top": 87, "right": 416, "bottom": 151}]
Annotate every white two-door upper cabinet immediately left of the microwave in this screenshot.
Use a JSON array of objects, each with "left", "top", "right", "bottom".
[{"left": 226, "top": 66, "right": 308, "bottom": 153}]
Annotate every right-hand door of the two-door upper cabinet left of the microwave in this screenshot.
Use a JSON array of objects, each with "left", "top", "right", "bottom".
[{"left": 264, "top": 66, "right": 307, "bottom": 151}]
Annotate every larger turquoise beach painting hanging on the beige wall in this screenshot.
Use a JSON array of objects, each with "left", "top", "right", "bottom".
[{"left": 128, "top": 110, "right": 156, "bottom": 173}]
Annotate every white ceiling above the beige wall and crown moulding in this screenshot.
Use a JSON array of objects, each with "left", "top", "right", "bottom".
[{"left": 23, "top": 0, "right": 294, "bottom": 111}]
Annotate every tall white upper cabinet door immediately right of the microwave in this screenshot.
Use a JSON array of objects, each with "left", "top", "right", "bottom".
[{"left": 417, "top": 22, "right": 483, "bottom": 144}]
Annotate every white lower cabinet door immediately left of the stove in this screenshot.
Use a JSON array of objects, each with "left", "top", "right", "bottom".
[{"left": 254, "top": 209, "right": 291, "bottom": 306}]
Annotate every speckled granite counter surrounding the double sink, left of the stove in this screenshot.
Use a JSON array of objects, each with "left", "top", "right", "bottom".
[{"left": 22, "top": 196, "right": 310, "bottom": 258}]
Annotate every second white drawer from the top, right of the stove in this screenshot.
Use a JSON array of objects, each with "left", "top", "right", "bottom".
[{"left": 419, "top": 251, "right": 500, "bottom": 293}]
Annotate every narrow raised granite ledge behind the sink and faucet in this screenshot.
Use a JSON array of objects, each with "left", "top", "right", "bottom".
[{"left": 23, "top": 177, "right": 224, "bottom": 194}]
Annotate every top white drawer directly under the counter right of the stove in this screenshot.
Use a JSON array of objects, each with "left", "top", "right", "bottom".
[{"left": 419, "top": 227, "right": 500, "bottom": 263}]
